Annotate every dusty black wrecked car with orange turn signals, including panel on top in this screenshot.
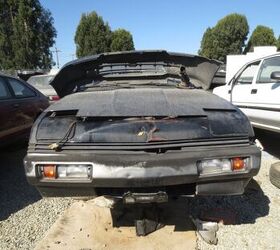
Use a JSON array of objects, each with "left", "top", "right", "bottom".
[{"left": 25, "top": 51, "right": 260, "bottom": 203}]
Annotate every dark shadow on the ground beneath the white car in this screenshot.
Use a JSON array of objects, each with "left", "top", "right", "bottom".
[{"left": 254, "top": 128, "right": 280, "bottom": 159}]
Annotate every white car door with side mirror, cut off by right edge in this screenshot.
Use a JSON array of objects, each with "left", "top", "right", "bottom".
[{"left": 247, "top": 55, "right": 280, "bottom": 132}]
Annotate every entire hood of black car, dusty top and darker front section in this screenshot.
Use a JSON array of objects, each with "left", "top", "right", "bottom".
[{"left": 35, "top": 88, "right": 253, "bottom": 144}]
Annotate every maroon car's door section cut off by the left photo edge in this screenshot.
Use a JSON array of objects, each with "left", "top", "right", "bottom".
[{"left": 0, "top": 76, "right": 17, "bottom": 139}]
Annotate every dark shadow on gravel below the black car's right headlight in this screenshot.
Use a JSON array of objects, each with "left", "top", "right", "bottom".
[{"left": 189, "top": 179, "right": 270, "bottom": 224}]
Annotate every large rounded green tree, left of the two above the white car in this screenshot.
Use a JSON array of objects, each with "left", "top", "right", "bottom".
[{"left": 199, "top": 14, "right": 249, "bottom": 61}]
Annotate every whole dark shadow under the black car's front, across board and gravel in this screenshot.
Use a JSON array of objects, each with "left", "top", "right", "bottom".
[{"left": 111, "top": 179, "right": 270, "bottom": 231}]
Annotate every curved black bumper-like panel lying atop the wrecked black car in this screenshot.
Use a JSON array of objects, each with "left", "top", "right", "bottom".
[{"left": 51, "top": 51, "right": 221, "bottom": 97}]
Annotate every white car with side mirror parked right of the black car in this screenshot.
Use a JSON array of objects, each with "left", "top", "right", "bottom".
[{"left": 214, "top": 53, "right": 280, "bottom": 133}]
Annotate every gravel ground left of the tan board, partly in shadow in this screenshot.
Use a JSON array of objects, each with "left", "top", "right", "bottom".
[{"left": 0, "top": 149, "right": 73, "bottom": 250}]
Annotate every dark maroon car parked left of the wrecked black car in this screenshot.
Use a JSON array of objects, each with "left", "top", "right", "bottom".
[{"left": 0, "top": 74, "right": 49, "bottom": 146}]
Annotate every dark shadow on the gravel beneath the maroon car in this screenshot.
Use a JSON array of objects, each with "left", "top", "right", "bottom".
[{"left": 0, "top": 143, "right": 41, "bottom": 221}]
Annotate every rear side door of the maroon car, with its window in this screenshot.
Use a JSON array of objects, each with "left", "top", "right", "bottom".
[{"left": 7, "top": 77, "right": 37, "bottom": 132}]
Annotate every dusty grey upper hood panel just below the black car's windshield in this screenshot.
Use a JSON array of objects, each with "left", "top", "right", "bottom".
[{"left": 48, "top": 88, "right": 237, "bottom": 117}]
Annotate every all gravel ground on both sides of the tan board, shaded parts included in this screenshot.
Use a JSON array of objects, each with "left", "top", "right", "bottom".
[{"left": 0, "top": 130, "right": 280, "bottom": 250}]
